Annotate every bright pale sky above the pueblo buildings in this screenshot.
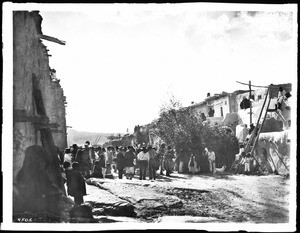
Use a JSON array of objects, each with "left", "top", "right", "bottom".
[{"left": 10, "top": 3, "right": 297, "bottom": 133}]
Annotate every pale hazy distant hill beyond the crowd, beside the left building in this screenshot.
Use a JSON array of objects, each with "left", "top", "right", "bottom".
[{"left": 67, "top": 128, "right": 112, "bottom": 146}]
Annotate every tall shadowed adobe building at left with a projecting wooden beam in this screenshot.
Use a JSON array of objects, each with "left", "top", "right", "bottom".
[{"left": 13, "top": 11, "right": 67, "bottom": 218}]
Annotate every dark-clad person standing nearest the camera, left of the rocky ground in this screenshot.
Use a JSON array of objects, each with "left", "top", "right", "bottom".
[{"left": 66, "top": 162, "right": 86, "bottom": 206}]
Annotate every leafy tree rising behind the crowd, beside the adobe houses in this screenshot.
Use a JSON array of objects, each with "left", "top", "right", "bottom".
[{"left": 156, "top": 97, "right": 238, "bottom": 171}]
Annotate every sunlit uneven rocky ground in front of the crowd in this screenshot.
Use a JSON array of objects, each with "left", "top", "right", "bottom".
[{"left": 68, "top": 170, "right": 290, "bottom": 223}]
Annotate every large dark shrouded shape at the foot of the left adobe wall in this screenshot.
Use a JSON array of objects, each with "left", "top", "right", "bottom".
[{"left": 13, "top": 145, "right": 62, "bottom": 215}]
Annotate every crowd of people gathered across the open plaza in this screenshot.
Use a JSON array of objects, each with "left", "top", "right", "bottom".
[{"left": 59, "top": 141, "right": 223, "bottom": 205}]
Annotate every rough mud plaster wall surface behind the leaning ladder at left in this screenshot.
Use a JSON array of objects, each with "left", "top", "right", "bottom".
[{"left": 13, "top": 11, "right": 67, "bottom": 177}]
